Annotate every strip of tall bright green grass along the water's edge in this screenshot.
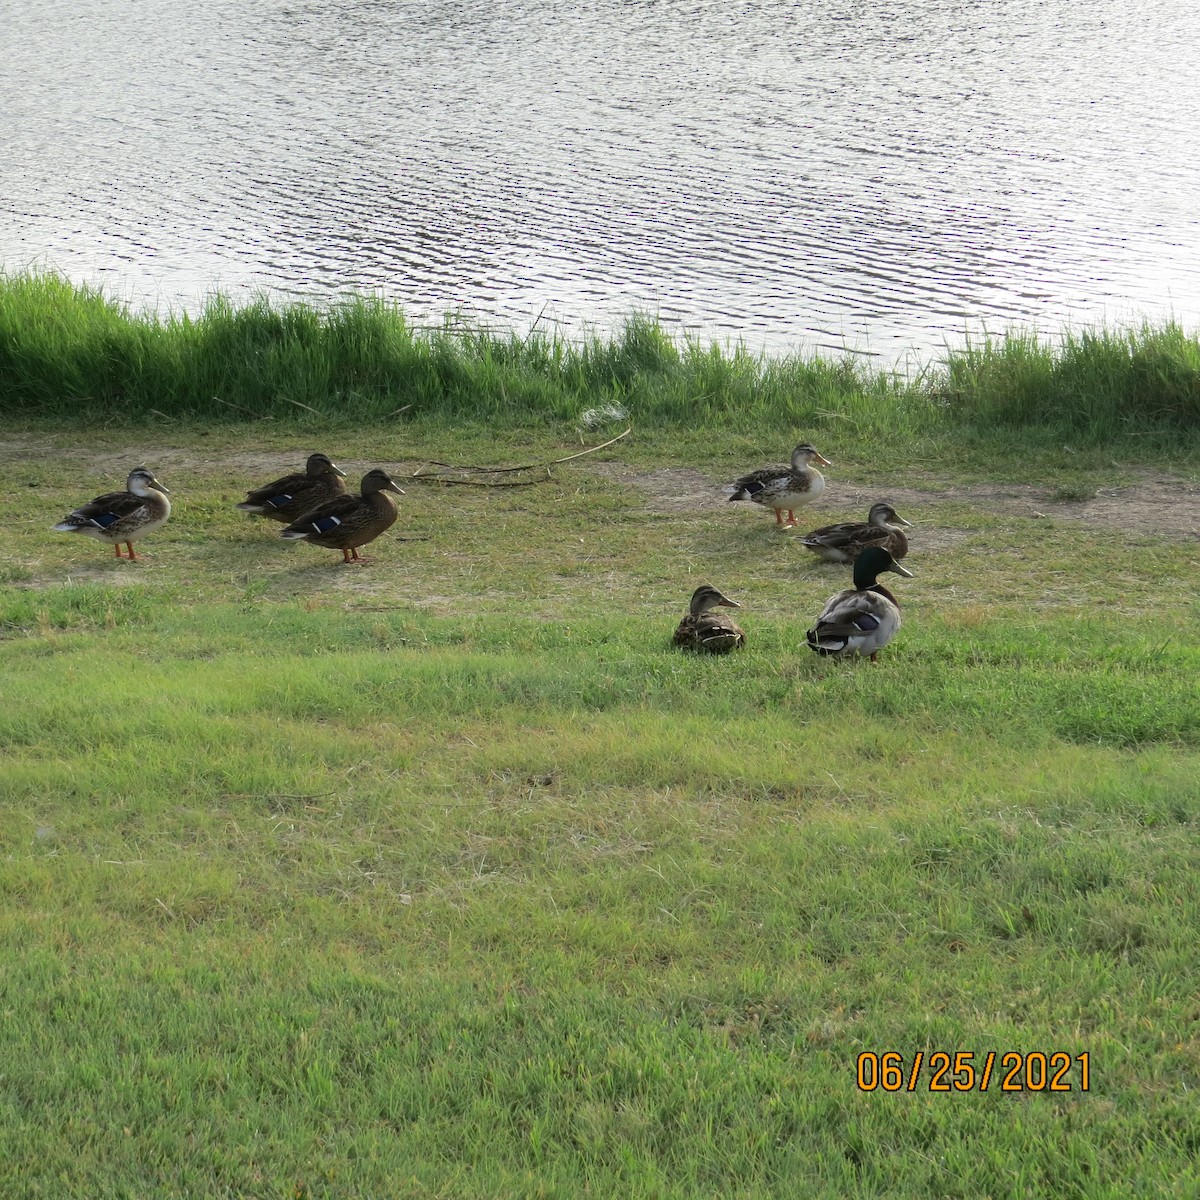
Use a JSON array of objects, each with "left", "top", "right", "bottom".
[{"left": 0, "top": 274, "right": 1200, "bottom": 443}]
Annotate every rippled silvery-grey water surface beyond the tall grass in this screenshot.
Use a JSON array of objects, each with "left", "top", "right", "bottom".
[{"left": 0, "top": 0, "right": 1200, "bottom": 360}]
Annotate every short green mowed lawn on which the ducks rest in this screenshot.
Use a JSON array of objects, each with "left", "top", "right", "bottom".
[{"left": 0, "top": 422, "right": 1200, "bottom": 1200}]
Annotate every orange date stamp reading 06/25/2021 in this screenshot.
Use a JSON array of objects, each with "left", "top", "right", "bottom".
[{"left": 857, "top": 1050, "right": 1092, "bottom": 1092}]
